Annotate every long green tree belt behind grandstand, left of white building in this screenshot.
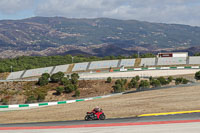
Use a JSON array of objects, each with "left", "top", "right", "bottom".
[{"left": 0, "top": 53, "right": 155, "bottom": 73}]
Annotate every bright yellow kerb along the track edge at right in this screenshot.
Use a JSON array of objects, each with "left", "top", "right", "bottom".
[{"left": 137, "top": 110, "right": 200, "bottom": 117}]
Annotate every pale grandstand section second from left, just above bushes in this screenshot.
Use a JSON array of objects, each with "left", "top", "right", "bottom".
[{"left": 22, "top": 67, "right": 53, "bottom": 78}]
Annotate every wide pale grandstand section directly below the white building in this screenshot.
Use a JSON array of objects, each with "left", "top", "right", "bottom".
[{"left": 157, "top": 57, "right": 187, "bottom": 65}]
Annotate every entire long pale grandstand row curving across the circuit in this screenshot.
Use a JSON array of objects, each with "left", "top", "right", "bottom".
[{"left": 6, "top": 56, "right": 200, "bottom": 80}]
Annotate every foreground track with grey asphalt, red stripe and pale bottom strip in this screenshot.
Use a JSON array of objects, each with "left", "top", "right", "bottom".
[{"left": 0, "top": 113, "right": 200, "bottom": 133}]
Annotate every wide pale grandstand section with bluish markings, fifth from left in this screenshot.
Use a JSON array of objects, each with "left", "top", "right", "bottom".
[{"left": 89, "top": 60, "right": 119, "bottom": 70}]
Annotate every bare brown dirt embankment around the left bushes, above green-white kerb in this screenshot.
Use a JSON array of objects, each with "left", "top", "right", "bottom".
[{"left": 0, "top": 80, "right": 115, "bottom": 104}]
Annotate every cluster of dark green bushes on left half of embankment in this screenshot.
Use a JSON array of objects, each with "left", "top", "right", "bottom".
[{"left": 25, "top": 72, "right": 80, "bottom": 103}]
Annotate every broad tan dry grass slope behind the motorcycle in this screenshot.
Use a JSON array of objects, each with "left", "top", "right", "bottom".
[{"left": 0, "top": 86, "right": 200, "bottom": 123}]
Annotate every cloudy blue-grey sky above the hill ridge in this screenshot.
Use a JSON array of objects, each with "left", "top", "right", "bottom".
[{"left": 0, "top": 0, "right": 200, "bottom": 26}]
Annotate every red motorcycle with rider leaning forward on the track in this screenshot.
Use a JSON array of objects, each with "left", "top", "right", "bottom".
[{"left": 85, "top": 110, "right": 106, "bottom": 121}]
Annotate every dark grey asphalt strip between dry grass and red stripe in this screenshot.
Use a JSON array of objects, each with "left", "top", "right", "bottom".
[{"left": 0, "top": 113, "right": 200, "bottom": 128}]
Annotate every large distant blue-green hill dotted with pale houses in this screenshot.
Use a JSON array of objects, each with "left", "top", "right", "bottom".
[{"left": 0, "top": 17, "right": 200, "bottom": 58}]
